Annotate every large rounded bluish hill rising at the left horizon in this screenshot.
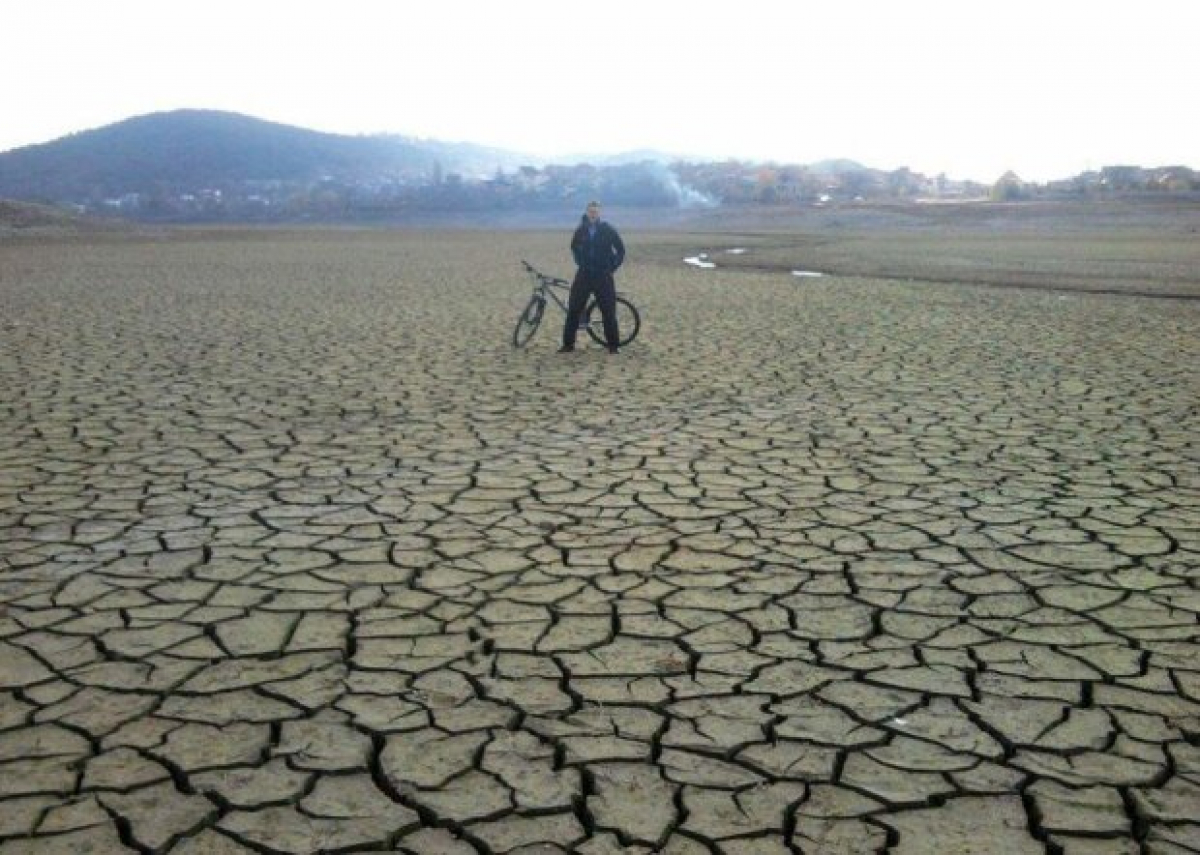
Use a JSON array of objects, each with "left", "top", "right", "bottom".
[{"left": 0, "top": 109, "right": 520, "bottom": 202}]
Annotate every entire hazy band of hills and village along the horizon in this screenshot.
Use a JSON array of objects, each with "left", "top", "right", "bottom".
[{"left": 0, "top": 109, "right": 1200, "bottom": 222}]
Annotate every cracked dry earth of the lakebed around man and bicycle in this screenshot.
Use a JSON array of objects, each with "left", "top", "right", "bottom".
[{"left": 0, "top": 232, "right": 1200, "bottom": 855}]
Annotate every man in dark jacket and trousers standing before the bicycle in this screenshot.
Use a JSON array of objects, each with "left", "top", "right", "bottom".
[{"left": 558, "top": 202, "right": 625, "bottom": 353}]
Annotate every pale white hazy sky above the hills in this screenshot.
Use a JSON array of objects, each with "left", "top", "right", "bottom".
[{"left": 0, "top": 0, "right": 1200, "bottom": 181}]
